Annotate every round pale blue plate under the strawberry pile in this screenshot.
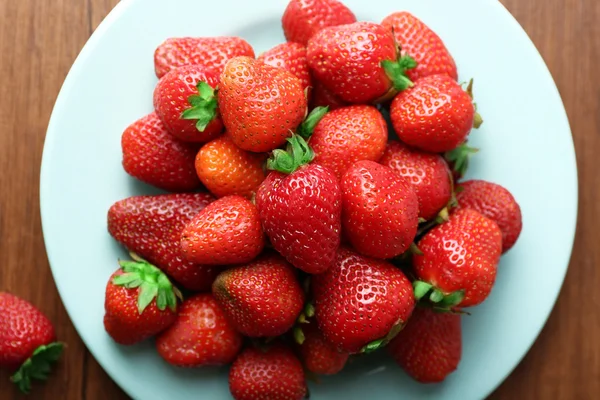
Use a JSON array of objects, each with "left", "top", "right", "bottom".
[{"left": 41, "top": 0, "right": 577, "bottom": 400}]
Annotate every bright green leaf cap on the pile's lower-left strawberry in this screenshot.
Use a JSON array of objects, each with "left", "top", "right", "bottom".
[{"left": 112, "top": 253, "right": 182, "bottom": 314}]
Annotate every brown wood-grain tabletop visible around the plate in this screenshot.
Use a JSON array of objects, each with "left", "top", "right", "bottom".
[{"left": 0, "top": 0, "right": 600, "bottom": 400}]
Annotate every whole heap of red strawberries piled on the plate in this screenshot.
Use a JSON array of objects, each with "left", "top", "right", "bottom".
[{"left": 104, "top": 0, "right": 521, "bottom": 399}]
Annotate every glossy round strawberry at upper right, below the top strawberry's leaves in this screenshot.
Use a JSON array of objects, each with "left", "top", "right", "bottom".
[{"left": 390, "top": 75, "right": 475, "bottom": 153}]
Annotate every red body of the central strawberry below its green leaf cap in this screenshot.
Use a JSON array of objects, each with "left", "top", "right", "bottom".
[{"left": 256, "top": 164, "right": 342, "bottom": 274}]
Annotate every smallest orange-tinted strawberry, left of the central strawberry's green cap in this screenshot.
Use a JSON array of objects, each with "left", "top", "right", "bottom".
[{"left": 196, "top": 135, "right": 266, "bottom": 197}]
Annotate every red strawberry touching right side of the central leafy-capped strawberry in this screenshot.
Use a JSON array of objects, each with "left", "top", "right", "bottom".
[{"left": 341, "top": 161, "right": 419, "bottom": 258}]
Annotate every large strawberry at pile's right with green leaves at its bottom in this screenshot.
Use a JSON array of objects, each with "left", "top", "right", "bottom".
[{"left": 413, "top": 208, "right": 502, "bottom": 308}]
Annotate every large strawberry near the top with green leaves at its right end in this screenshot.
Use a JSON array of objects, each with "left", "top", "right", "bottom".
[{"left": 307, "top": 22, "right": 415, "bottom": 103}]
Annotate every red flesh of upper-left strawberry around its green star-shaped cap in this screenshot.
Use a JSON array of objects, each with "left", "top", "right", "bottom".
[{"left": 153, "top": 65, "right": 223, "bottom": 143}]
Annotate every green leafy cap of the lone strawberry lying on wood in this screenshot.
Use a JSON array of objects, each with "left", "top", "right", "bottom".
[{"left": 10, "top": 342, "right": 64, "bottom": 394}]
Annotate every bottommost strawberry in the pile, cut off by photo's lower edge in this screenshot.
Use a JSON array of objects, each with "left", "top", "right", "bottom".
[{"left": 229, "top": 343, "right": 308, "bottom": 400}]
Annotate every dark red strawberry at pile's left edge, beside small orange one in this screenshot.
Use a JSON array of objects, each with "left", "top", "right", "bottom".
[{"left": 121, "top": 113, "right": 200, "bottom": 192}]
